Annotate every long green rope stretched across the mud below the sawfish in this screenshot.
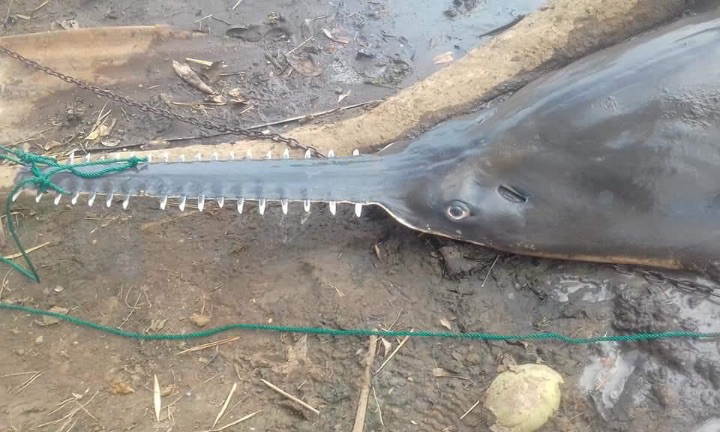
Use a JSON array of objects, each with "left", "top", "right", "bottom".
[{"left": 0, "top": 302, "right": 720, "bottom": 345}]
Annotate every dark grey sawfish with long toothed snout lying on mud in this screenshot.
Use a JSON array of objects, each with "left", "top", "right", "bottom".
[{"left": 12, "top": 11, "right": 720, "bottom": 271}]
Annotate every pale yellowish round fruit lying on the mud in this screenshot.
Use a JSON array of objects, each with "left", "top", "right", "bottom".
[{"left": 485, "top": 364, "right": 564, "bottom": 432}]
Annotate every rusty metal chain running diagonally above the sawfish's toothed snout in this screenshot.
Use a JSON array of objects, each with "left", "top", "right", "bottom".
[{"left": 0, "top": 46, "right": 325, "bottom": 158}]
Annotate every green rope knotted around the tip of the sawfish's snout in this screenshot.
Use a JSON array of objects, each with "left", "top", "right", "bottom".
[{"left": 0, "top": 146, "right": 147, "bottom": 282}]
